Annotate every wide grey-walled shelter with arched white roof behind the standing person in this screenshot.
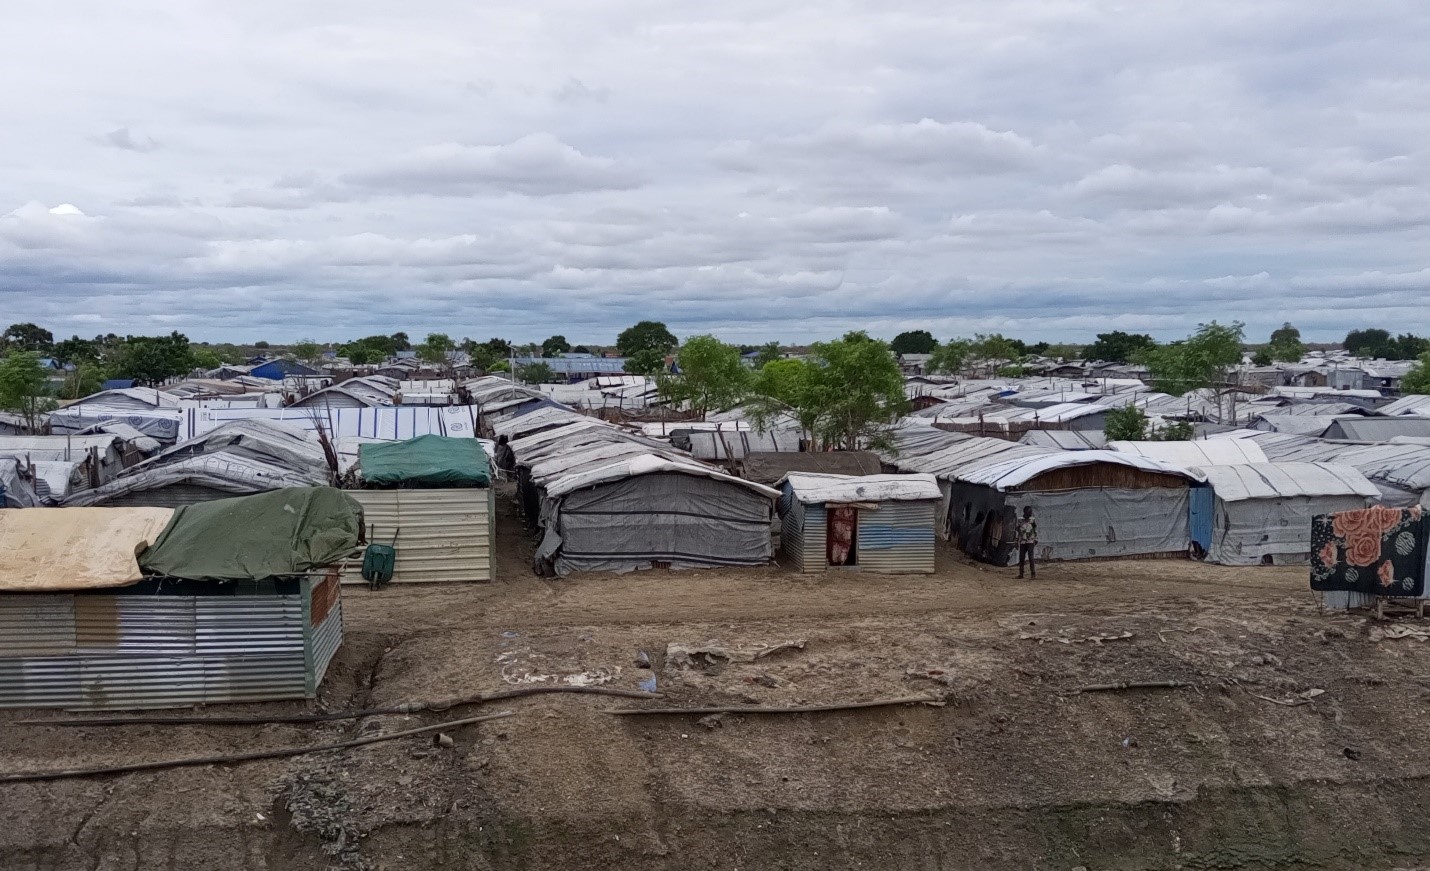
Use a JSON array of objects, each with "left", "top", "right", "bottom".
[{"left": 947, "top": 451, "right": 1204, "bottom": 565}]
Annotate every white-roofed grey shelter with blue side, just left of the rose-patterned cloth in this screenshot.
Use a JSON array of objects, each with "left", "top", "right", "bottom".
[{"left": 1188, "top": 462, "right": 1380, "bottom": 565}]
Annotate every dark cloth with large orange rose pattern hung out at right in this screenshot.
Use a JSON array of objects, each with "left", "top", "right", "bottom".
[{"left": 1311, "top": 505, "right": 1427, "bottom": 596}]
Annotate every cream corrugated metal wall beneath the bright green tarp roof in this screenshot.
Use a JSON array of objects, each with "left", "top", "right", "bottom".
[{"left": 343, "top": 488, "right": 496, "bottom": 584}]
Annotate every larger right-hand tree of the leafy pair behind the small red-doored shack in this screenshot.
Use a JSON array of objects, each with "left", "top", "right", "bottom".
[{"left": 808, "top": 332, "right": 908, "bottom": 451}]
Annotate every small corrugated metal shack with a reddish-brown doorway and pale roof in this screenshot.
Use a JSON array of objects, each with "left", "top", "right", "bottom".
[{"left": 778, "top": 472, "right": 942, "bottom": 575}]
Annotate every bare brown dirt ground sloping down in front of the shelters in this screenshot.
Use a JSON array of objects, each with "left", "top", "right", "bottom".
[{"left": 0, "top": 486, "right": 1430, "bottom": 871}]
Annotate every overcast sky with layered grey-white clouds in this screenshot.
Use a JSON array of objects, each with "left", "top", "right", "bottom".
[{"left": 0, "top": 0, "right": 1430, "bottom": 342}]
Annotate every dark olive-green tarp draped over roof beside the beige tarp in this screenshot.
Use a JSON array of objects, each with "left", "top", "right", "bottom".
[{"left": 139, "top": 486, "right": 362, "bottom": 581}]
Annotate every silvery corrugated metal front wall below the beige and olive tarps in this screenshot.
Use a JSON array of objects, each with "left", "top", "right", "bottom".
[{"left": 0, "top": 594, "right": 326, "bottom": 708}]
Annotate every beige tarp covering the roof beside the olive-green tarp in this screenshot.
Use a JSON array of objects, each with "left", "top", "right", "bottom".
[{"left": 0, "top": 508, "right": 173, "bottom": 592}]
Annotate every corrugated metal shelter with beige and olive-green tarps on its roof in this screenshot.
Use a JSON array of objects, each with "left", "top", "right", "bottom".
[{"left": 0, "top": 488, "right": 362, "bottom": 709}]
